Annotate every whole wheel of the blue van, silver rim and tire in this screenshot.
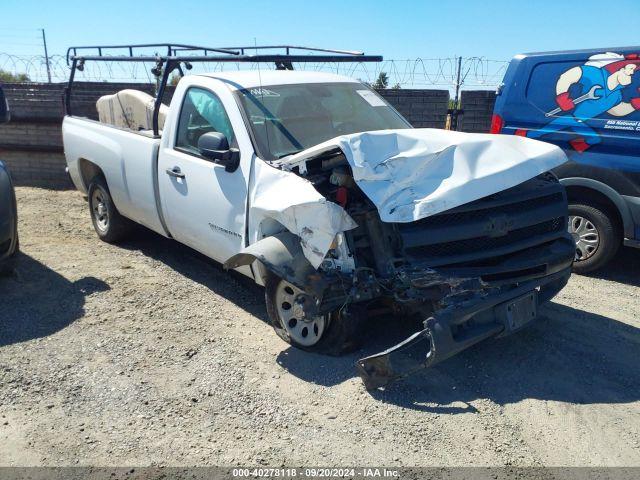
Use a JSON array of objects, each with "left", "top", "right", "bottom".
[{"left": 569, "top": 203, "right": 622, "bottom": 273}]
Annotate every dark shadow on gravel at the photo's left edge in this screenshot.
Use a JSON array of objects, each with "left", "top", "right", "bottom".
[{"left": 0, "top": 253, "right": 109, "bottom": 347}]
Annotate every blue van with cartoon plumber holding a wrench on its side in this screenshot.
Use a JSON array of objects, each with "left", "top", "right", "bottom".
[{"left": 491, "top": 47, "right": 640, "bottom": 273}]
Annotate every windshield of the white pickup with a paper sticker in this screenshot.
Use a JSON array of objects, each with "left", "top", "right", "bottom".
[{"left": 238, "top": 83, "right": 411, "bottom": 160}]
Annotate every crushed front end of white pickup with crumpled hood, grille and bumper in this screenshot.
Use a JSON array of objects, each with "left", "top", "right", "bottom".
[{"left": 225, "top": 128, "right": 574, "bottom": 389}]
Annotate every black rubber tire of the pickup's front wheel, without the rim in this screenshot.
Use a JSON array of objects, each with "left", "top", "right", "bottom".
[{"left": 265, "top": 274, "right": 364, "bottom": 356}]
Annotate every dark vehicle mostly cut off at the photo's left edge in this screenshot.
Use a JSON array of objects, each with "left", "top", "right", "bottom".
[{"left": 0, "top": 86, "right": 18, "bottom": 273}]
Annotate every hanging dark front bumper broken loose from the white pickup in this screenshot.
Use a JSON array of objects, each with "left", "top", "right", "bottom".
[{"left": 356, "top": 266, "right": 571, "bottom": 390}]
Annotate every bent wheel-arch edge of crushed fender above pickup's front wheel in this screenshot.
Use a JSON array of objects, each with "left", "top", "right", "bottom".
[{"left": 223, "top": 232, "right": 327, "bottom": 298}]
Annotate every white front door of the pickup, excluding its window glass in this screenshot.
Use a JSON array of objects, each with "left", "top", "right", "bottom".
[{"left": 158, "top": 76, "right": 254, "bottom": 262}]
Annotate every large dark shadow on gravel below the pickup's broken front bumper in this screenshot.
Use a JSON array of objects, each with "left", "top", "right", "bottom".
[{"left": 278, "top": 303, "right": 640, "bottom": 413}]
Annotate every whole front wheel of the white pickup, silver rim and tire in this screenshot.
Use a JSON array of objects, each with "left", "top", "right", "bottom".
[{"left": 265, "top": 274, "right": 362, "bottom": 355}]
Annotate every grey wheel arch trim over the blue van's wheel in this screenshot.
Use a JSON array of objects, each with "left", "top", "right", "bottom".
[{"left": 560, "top": 177, "right": 634, "bottom": 237}]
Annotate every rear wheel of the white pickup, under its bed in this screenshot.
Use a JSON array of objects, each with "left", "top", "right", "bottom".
[{"left": 88, "top": 175, "right": 133, "bottom": 243}]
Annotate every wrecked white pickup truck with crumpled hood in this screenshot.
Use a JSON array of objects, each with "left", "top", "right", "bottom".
[{"left": 63, "top": 47, "right": 574, "bottom": 388}]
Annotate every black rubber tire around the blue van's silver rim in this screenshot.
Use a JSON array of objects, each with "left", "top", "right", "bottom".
[{"left": 569, "top": 202, "right": 622, "bottom": 273}]
